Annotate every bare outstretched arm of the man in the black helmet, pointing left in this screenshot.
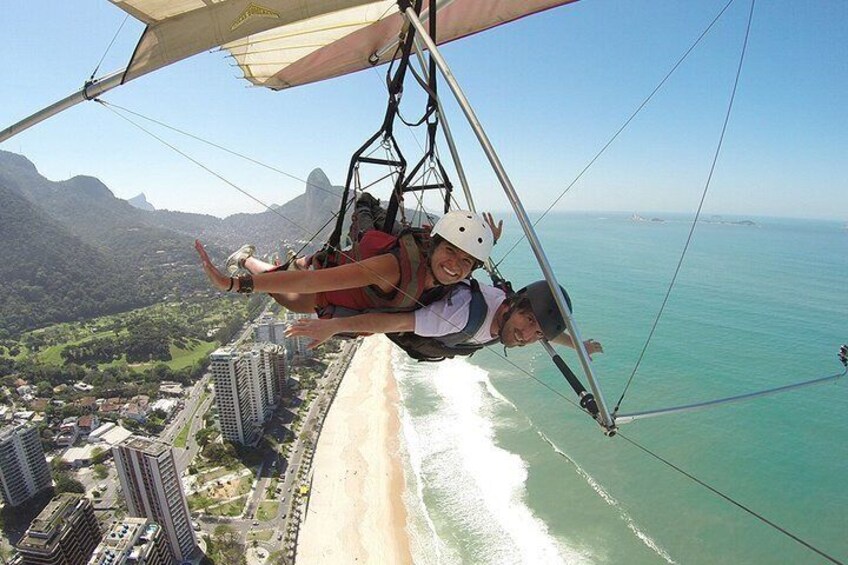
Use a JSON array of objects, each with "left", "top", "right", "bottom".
[{"left": 286, "top": 312, "right": 415, "bottom": 349}]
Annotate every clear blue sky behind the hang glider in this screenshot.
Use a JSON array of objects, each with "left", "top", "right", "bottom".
[{"left": 0, "top": 0, "right": 848, "bottom": 221}]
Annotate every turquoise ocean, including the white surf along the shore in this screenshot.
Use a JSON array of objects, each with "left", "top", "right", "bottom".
[{"left": 394, "top": 214, "right": 848, "bottom": 564}]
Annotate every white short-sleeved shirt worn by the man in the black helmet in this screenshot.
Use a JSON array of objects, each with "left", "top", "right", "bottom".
[{"left": 413, "top": 282, "right": 506, "bottom": 343}]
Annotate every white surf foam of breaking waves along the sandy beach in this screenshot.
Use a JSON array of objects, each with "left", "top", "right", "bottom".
[{"left": 395, "top": 352, "right": 590, "bottom": 563}]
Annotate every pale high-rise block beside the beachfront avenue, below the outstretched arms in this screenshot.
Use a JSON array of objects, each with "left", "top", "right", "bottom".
[{"left": 209, "top": 343, "right": 285, "bottom": 445}]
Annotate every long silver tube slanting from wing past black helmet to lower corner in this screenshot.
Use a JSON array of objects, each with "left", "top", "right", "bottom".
[{"left": 404, "top": 8, "right": 615, "bottom": 430}]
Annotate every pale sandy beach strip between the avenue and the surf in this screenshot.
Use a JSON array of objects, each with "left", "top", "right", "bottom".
[{"left": 297, "top": 336, "right": 412, "bottom": 564}]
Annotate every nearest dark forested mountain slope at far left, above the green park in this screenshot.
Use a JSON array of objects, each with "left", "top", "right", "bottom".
[{"left": 0, "top": 151, "right": 214, "bottom": 333}]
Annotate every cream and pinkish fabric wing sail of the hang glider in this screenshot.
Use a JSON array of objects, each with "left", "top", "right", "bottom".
[{"left": 110, "top": 0, "right": 576, "bottom": 89}]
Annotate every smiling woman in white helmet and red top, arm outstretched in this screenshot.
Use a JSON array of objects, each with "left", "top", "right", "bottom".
[{"left": 195, "top": 205, "right": 500, "bottom": 318}]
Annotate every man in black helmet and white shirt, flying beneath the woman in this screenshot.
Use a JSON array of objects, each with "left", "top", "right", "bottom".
[{"left": 287, "top": 279, "right": 603, "bottom": 361}]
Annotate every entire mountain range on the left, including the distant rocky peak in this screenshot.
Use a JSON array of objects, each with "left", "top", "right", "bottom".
[{"left": 0, "top": 151, "right": 352, "bottom": 334}]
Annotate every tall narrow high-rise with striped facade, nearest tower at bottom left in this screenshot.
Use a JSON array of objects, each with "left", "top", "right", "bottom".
[{"left": 112, "top": 436, "right": 197, "bottom": 562}]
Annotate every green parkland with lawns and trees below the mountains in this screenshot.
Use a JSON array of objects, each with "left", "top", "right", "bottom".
[{"left": 0, "top": 296, "right": 262, "bottom": 410}]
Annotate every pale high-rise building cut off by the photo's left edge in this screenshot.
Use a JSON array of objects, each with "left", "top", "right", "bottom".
[{"left": 0, "top": 425, "right": 52, "bottom": 506}]
